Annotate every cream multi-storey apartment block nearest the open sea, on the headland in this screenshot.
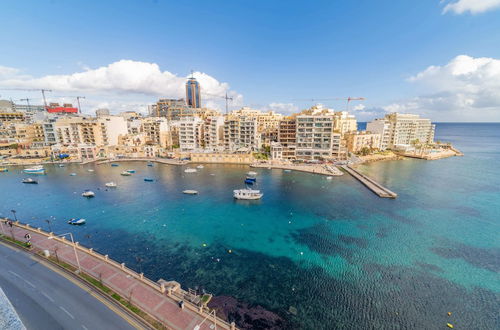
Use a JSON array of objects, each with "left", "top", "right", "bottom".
[{"left": 366, "top": 113, "right": 435, "bottom": 150}]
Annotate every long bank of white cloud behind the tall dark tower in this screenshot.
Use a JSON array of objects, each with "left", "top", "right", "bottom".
[{"left": 0, "top": 60, "right": 243, "bottom": 114}]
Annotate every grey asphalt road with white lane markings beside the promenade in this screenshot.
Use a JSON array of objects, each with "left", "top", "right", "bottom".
[{"left": 0, "top": 243, "right": 141, "bottom": 330}]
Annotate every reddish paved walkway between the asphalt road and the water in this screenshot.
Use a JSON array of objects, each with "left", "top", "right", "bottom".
[{"left": 3, "top": 223, "right": 231, "bottom": 330}]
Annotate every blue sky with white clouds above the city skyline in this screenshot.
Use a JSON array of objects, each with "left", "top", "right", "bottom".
[{"left": 0, "top": 0, "right": 500, "bottom": 122}]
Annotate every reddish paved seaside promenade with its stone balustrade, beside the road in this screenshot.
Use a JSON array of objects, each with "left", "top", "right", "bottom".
[{"left": 0, "top": 219, "right": 236, "bottom": 330}]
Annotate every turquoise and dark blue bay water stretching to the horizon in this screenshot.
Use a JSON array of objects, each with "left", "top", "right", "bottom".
[{"left": 0, "top": 123, "right": 500, "bottom": 329}]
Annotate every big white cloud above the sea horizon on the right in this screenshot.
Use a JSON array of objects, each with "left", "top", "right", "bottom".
[{"left": 383, "top": 55, "right": 500, "bottom": 121}]
